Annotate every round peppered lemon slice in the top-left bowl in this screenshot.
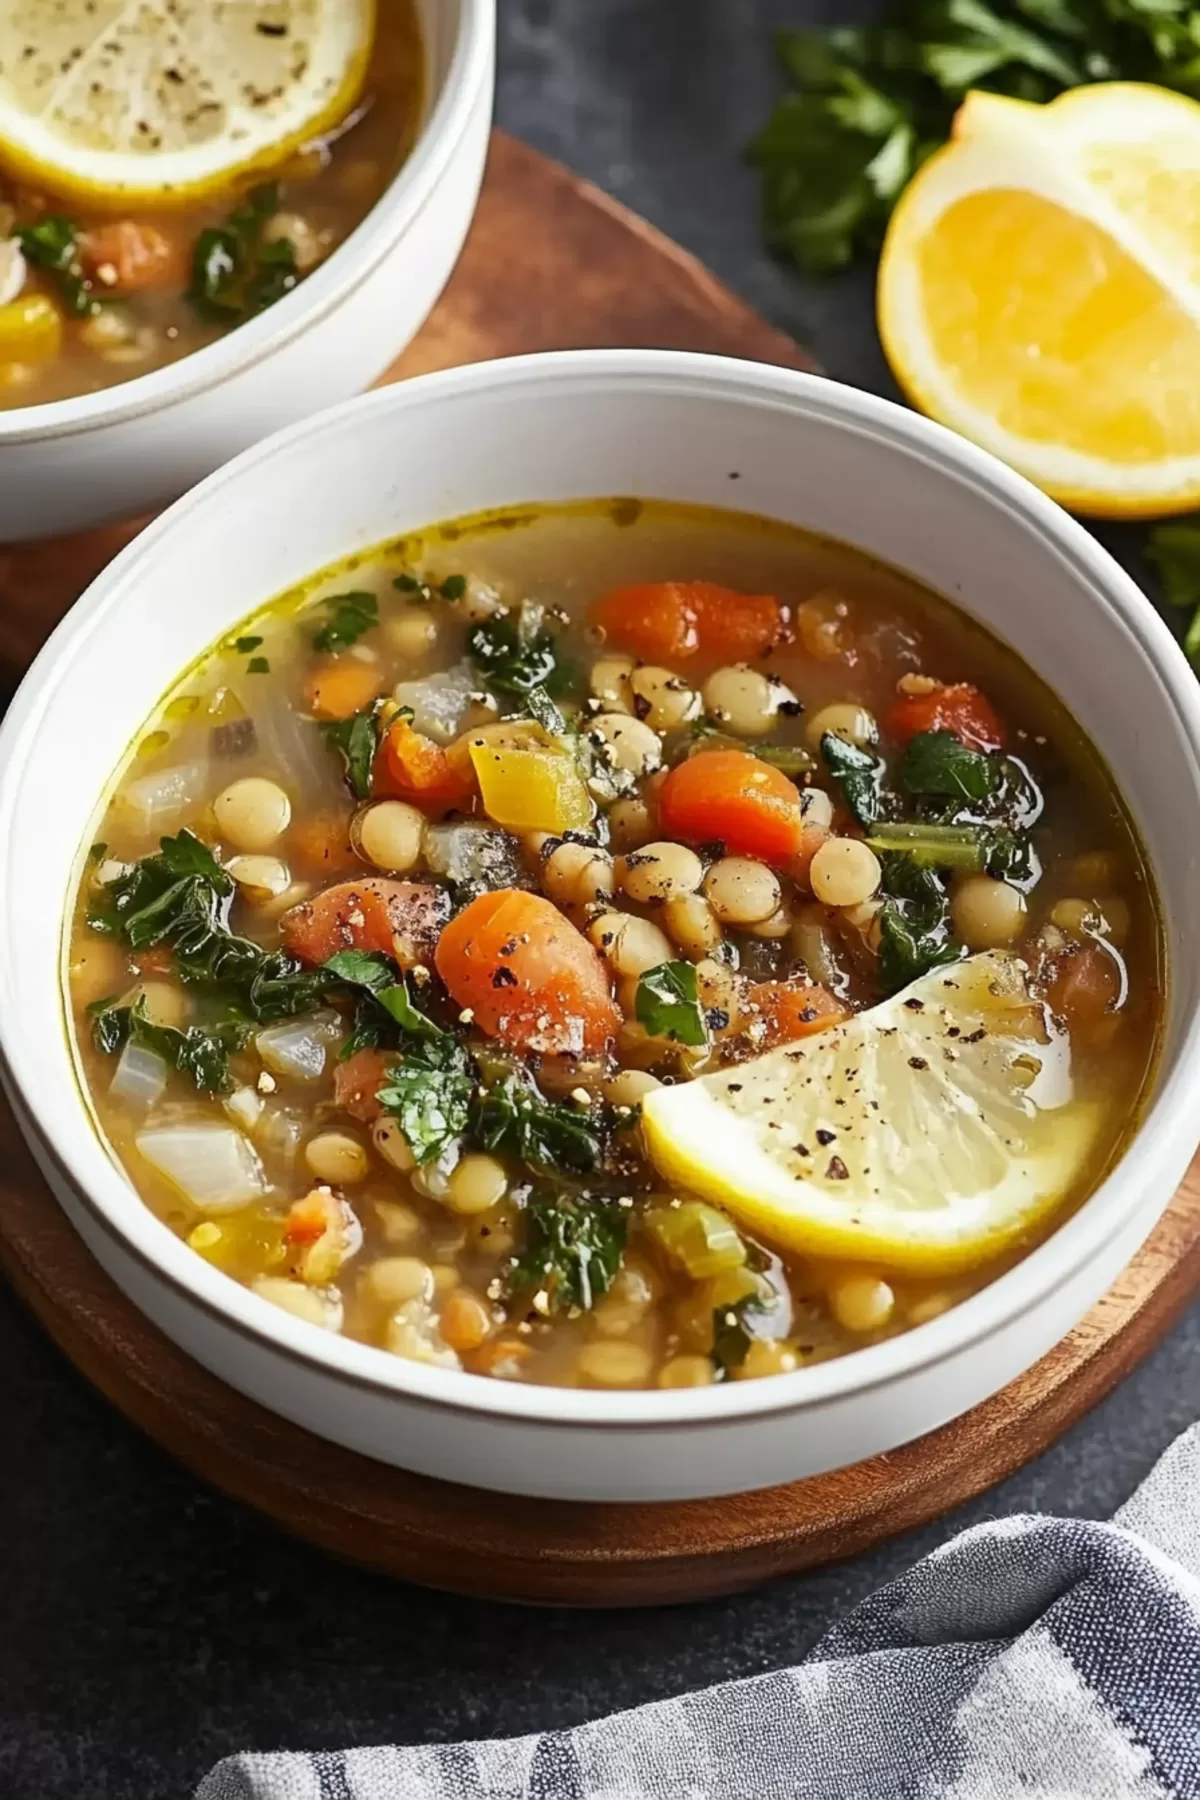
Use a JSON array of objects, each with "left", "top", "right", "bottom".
[{"left": 0, "top": 0, "right": 374, "bottom": 205}]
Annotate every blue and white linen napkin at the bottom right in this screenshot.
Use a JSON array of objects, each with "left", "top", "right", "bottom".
[{"left": 196, "top": 1426, "right": 1200, "bottom": 1800}]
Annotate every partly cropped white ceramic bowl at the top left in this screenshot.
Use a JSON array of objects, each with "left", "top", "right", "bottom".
[{"left": 0, "top": 0, "right": 495, "bottom": 544}]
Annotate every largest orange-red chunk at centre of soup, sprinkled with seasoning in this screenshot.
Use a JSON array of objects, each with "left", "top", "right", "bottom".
[{"left": 435, "top": 887, "right": 621, "bottom": 1057}]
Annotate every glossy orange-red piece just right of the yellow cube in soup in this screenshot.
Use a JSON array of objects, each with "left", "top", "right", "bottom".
[{"left": 658, "top": 751, "right": 805, "bottom": 868}]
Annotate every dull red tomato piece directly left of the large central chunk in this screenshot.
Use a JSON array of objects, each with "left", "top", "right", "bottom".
[{"left": 279, "top": 875, "right": 450, "bottom": 968}]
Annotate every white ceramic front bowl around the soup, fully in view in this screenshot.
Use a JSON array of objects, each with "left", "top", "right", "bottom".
[{"left": 0, "top": 351, "right": 1200, "bottom": 1499}]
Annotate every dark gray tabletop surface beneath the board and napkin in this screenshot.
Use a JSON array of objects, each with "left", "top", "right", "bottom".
[{"left": 0, "top": 0, "right": 1200, "bottom": 1800}]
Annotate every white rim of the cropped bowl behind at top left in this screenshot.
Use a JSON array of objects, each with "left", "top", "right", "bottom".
[{"left": 0, "top": 0, "right": 497, "bottom": 450}]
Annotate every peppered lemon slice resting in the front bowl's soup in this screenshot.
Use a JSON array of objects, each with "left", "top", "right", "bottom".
[{"left": 642, "top": 952, "right": 1099, "bottom": 1274}]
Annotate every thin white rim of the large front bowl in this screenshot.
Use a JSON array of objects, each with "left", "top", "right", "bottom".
[{"left": 0, "top": 349, "right": 1200, "bottom": 1431}]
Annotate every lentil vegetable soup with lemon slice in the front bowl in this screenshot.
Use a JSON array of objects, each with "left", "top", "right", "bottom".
[{"left": 67, "top": 500, "right": 1162, "bottom": 1388}]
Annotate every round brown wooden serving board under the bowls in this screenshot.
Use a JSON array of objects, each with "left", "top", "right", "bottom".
[{"left": 0, "top": 135, "right": 1200, "bottom": 1606}]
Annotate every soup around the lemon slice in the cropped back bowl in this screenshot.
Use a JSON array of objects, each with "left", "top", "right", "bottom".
[{"left": 0, "top": 0, "right": 425, "bottom": 407}]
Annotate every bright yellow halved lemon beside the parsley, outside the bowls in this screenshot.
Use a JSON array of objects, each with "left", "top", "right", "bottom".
[{"left": 878, "top": 83, "right": 1200, "bottom": 517}]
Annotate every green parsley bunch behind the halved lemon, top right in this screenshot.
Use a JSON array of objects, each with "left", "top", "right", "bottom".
[{"left": 750, "top": 0, "right": 1200, "bottom": 274}]
